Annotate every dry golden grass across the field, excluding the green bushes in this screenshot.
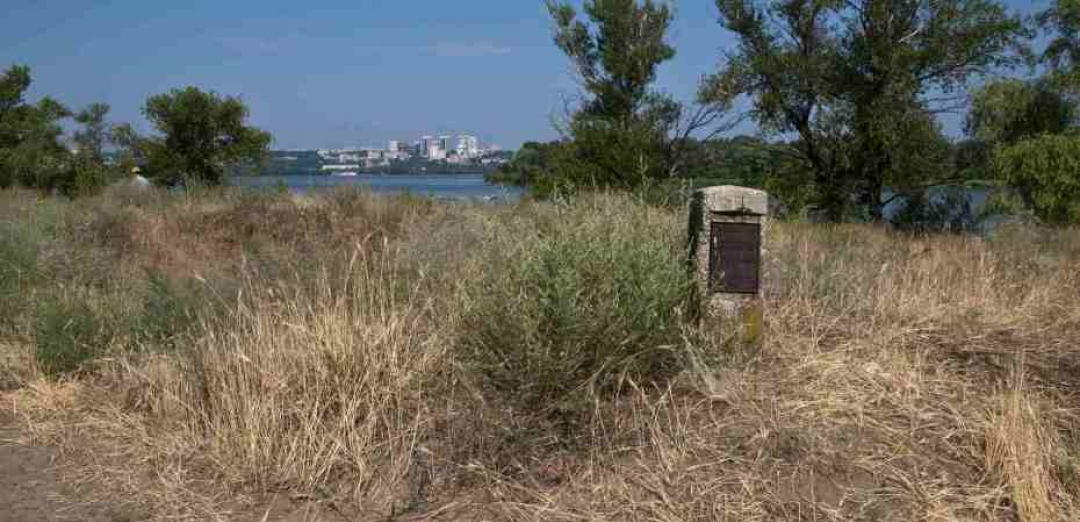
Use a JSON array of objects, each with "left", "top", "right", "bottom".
[{"left": 0, "top": 190, "right": 1080, "bottom": 522}]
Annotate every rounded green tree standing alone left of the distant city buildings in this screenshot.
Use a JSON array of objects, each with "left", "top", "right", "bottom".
[{"left": 126, "top": 86, "right": 271, "bottom": 185}]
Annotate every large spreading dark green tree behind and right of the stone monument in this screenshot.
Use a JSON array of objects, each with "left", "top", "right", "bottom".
[{"left": 702, "top": 0, "right": 1026, "bottom": 222}]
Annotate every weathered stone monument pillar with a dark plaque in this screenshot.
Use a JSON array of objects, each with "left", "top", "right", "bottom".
[{"left": 689, "top": 186, "right": 769, "bottom": 346}]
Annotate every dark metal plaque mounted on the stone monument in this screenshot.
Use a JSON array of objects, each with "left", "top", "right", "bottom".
[{"left": 708, "top": 222, "right": 761, "bottom": 294}]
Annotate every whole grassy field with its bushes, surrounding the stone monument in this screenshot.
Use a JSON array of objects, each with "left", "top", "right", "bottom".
[{"left": 0, "top": 185, "right": 1080, "bottom": 522}]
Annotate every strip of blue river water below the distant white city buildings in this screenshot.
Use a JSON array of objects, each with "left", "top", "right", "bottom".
[{"left": 233, "top": 174, "right": 524, "bottom": 201}]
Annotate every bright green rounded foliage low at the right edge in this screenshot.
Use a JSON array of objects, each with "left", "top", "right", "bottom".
[{"left": 994, "top": 134, "right": 1080, "bottom": 225}]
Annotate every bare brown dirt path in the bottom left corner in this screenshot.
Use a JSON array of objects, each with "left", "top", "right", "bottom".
[{"left": 0, "top": 412, "right": 115, "bottom": 522}]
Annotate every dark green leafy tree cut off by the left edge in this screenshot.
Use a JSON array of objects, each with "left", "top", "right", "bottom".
[{"left": 0, "top": 65, "right": 70, "bottom": 188}]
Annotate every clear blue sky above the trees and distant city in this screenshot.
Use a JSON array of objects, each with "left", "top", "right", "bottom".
[{"left": 0, "top": 0, "right": 1048, "bottom": 148}]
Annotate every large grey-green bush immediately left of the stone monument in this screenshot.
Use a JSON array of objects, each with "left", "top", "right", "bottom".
[{"left": 461, "top": 197, "right": 690, "bottom": 412}]
